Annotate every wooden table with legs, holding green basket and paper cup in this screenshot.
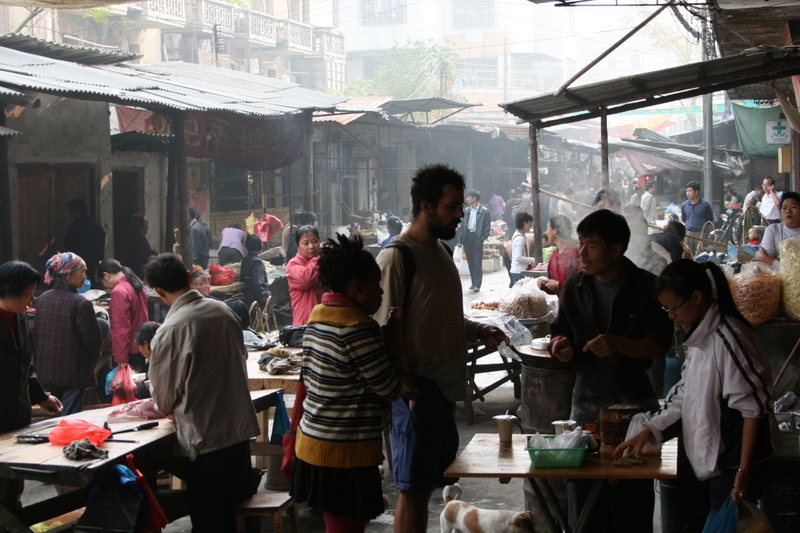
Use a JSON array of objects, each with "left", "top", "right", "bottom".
[{"left": 444, "top": 433, "right": 678, "bottom": 533}]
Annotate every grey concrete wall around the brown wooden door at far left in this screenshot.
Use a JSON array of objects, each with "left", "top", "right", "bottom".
[{"left": 6, "top": 93, "right": 113, "bottom": 255}]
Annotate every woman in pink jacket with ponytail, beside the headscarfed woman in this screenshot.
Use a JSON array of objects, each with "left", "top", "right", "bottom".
[{"left": 97, "top": 259, "right": 148, "bottom": 372}]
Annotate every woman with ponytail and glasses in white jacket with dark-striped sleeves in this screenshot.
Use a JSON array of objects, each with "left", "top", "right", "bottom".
[{"left": 614, "top": 259, "right": 781, "bottom": 511}]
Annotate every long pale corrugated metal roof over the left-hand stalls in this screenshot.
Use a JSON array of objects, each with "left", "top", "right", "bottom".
[{"left": 0, "top": 47, "right": 354, "bottom": 116}]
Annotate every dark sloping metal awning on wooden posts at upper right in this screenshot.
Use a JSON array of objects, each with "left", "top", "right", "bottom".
[{"left": 500, "top": 46, "right": 800, "bottom": 128}]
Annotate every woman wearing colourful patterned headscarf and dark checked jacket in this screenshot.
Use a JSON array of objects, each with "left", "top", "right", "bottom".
[{"left": 34, "top": 252, "right": 102, "bottom": 415}]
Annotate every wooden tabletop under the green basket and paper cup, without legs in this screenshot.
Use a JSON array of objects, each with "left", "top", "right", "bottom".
[{"left": 444, "top": 433, "right": 678, "bottom": 479}]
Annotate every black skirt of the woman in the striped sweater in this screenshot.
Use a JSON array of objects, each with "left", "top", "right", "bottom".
[{"left": 289, "top": 458, "right": 385, "bottom": 520}]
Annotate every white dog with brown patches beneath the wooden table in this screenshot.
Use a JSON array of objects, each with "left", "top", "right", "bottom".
[{"left": 439, "top": 483, "right": 534, "bottom": 533}]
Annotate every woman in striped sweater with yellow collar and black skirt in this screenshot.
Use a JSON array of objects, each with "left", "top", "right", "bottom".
[{"left": 290, "top": 235, "right": 402, "bottom": 533}]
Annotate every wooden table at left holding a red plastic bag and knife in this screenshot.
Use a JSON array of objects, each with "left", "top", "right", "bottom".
[{"left": 0, "top": 389, "right": 279, "bottom": 533}]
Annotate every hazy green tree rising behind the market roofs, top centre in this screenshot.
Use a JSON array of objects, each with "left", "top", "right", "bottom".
[{"left": 341, "top": 40, "right": 457, "bottom": 99}]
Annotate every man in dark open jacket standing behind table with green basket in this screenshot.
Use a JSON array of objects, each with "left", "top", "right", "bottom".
[{"left": 549, "top": 209, "right": 672, "bottom": 532}]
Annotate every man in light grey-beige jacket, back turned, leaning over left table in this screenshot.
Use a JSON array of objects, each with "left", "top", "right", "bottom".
[{"left": 145, "top": 254, "right": 260, "bottom": 533}]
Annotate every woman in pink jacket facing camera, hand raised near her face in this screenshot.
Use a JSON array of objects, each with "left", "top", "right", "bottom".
[{"left": 286, "top": 226, "right": 322, "bottom": 326}]
